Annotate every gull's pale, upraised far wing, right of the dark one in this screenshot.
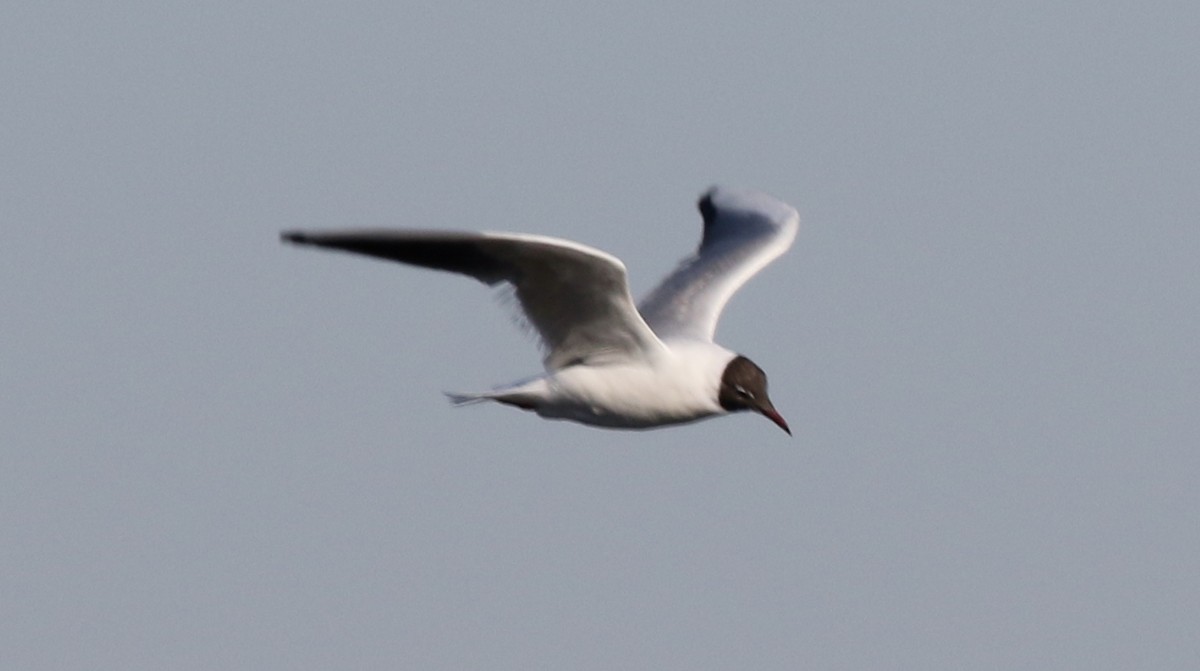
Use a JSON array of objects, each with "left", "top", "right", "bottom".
[{"left": 638, "top": 187, "right": 800, "bottom": 341}]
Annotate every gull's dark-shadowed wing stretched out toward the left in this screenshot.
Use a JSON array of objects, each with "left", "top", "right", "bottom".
[{"left": 282, "top": 229, "right": 664, "bottom": 371}]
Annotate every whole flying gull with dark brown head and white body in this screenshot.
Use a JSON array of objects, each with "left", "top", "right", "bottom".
[{"left": 282, "top": 187, "right": 800, "bottom": 435}]
